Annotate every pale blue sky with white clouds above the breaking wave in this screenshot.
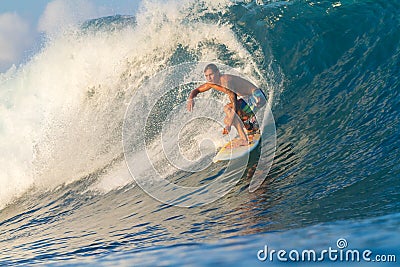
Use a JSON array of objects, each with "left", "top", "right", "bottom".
[{"left": 0, "top": 0, "right": 140, "bottom": 72}]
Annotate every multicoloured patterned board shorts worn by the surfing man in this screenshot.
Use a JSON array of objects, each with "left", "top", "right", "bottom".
[{"left": 237, "top": 89, "right": 266, "bottom": 133}]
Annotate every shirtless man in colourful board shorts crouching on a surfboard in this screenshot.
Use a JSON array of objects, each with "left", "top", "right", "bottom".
[{"left": 187, "top": 64, "right": 266, "bottom": 146}]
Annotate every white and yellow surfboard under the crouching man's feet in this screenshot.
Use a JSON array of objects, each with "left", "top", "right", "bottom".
[{"left": 213, "top": 134, "right": 261, "bottom": 163}]
